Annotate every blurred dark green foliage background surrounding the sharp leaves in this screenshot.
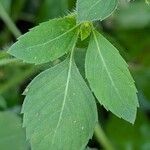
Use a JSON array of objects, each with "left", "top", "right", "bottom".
[{"left": 0, "top": 0, "right": 150, "bottom": 150}]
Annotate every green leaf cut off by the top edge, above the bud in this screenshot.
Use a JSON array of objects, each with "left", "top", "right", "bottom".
[{"left": 77, "top": 0, "right": 118, "bottom": 22}]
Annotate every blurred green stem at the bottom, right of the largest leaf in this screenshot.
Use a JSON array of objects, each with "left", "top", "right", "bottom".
[{"left": 94, "top": 124, "right": 114, "bottom": 150}]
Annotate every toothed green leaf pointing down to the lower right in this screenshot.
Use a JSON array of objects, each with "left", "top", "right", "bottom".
[{"left": 86, "top": 31, "right": 139, "bottom": 123}]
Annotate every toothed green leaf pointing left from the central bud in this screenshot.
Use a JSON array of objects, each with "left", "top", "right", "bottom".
[{"left": 8, "top": 16, "right": 77, "bottom": 64}]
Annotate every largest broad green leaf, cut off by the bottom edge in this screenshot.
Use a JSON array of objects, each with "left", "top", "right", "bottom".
[{"left": 22, "top": 53, "right": 97, "bottom": 150}]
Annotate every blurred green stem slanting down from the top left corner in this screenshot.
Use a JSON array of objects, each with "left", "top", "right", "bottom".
[{"left": 0, "top": 2, "right": 21, "bottom": 38}]
